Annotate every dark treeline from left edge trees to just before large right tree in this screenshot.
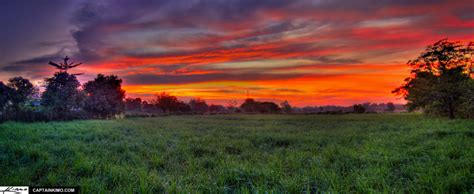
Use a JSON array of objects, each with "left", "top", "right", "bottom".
[{"left": 0, "top": 71, "right": 403, "bottom": 121}]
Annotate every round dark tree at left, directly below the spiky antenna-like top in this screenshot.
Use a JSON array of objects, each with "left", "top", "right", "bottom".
[{"left": 41, "top": 72, "right": 84, "bottom": 119}]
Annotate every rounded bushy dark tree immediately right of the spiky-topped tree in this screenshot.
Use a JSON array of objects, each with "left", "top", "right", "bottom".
[{"left": 84, "top": 74, "right": 125, "bottom": 118}]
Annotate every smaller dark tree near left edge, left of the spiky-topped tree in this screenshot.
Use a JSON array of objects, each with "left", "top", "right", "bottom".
[{"left": 8, "top": 77, "right": 35, "bottom": 114}]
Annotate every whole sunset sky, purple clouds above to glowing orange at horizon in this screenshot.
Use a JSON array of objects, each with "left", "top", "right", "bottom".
[{"left": 0, "top": 0, "right": 474, "bottom": 106}]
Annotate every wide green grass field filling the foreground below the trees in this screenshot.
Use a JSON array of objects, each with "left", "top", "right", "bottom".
[{"left": 0, "top": 114, "right": 474, "bottom": 193}]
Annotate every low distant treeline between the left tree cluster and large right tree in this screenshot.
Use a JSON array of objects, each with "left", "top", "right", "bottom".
[{"left": 125, "top": 93, "right": 406, "bottom": 116}]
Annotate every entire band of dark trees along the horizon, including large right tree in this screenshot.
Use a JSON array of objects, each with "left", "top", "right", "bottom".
[{"left": 0, "top": 39, "right": 474, "bottom": 121}]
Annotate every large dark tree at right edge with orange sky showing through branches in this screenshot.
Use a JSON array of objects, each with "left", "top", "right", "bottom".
[{"left": 393, "top": 39, "right": 473, "bottom": 118}]
